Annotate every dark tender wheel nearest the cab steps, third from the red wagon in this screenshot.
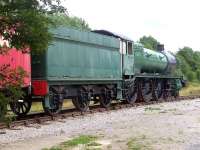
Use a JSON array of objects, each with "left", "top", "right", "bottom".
[{"left": 100, "top": 89, "right": 112, "bottom": 108}]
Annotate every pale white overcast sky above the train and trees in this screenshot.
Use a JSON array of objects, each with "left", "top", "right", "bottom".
[{"left": 63, "top": 0, "right": 200, "bottom": 51}]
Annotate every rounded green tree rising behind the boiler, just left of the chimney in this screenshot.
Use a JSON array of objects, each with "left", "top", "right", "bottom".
[{"left": 139, "top": 36, "right": 160, "bottom": 50}]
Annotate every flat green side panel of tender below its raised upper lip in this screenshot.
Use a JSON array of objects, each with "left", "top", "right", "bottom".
[{"left": 47, "top": 39, "right": 121, "bottom": 79}]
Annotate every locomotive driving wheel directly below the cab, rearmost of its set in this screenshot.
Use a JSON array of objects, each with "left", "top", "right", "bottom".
[{"left": 126, "top": 82, "right": 138, "bottom": 104}]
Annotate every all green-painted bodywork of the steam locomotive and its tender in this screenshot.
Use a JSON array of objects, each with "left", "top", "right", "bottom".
[{"left": 29, "top": 28, "right": 181, "bottom": 103}]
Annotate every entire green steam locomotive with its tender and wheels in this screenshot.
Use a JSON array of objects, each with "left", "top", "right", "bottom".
[{"left": 1, "top": 27, "right": 182, "bottom": 115}]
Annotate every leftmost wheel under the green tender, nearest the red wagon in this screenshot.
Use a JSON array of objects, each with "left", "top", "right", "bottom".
[{"left": 42, "top": 91, "right": 63, "bottom": 115}]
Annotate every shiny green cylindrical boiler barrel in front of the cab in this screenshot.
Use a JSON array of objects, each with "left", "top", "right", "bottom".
[{"left": 134, "top": 44, "right": 168, "bottom": 73}]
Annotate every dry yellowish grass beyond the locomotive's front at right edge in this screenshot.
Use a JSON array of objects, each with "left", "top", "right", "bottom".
[{"left": 180, "top": 82, "right": 200, "bottom": 96}]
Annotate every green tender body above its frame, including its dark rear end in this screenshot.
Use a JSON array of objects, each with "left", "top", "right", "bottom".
[{"left": 32, "top": 28, "right": 122, "bottom": 81}]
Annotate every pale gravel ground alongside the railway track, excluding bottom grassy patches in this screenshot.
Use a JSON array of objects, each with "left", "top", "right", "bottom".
[{"left": 0, "top": 99, "right": 200, "bottom": 150}]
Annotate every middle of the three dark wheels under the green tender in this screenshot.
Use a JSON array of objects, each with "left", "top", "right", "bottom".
[{"left": 72, "top": 90, "right": 90, "bottom": 112}]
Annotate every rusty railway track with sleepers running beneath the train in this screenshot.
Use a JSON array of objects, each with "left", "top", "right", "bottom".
[{"left": 0, "top": 95, "right": 200, "bottom": 130}]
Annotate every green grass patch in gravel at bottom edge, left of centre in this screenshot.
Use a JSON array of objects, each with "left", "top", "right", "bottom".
[{"left": 43, "top": 135, "right": 101, "bottom": 150}]
